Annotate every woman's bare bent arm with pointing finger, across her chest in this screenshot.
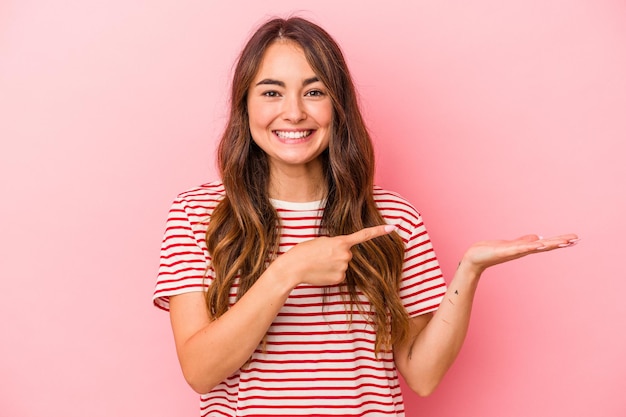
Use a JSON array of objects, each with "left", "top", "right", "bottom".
[{"left": 170, "top": 226, "right": 395, "bottom": 393}]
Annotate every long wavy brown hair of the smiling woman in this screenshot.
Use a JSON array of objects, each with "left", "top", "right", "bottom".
[{"left": 206, "top": 17, "right": 409, "bottom": 353}]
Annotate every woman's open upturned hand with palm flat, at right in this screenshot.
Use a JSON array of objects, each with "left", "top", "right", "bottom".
[{"left": 461, "top": 233, "right": 579, "bottom": 275}]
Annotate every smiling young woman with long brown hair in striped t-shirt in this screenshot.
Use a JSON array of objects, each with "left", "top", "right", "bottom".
[{"left": 154, "top": 18, "right": 577, "bottom": 416}]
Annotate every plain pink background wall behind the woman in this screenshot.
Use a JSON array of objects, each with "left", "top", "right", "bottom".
[{"left": 0, "top": 0, "right": 626, "bottom": 417}]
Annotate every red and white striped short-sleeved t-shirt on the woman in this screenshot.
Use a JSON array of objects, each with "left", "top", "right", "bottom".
[{"left": 154, "top": 182, "right": 446, "bottom": 416}]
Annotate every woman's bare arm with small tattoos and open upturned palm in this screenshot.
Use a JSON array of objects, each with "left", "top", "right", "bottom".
[{"left": 394, "top": 234, "right": 578, "bottom": 396}]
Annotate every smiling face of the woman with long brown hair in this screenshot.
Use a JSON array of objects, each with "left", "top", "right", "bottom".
[{"left": 248, "top": 41, "right": 333, "bottom": 174}]
